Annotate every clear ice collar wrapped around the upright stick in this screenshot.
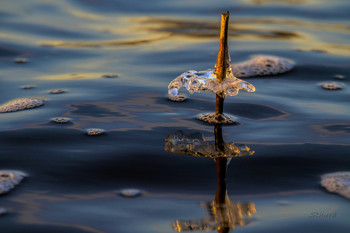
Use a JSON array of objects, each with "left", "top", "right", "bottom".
[{"left": 168, "top": 69, "right": 255, "bottom": 100}]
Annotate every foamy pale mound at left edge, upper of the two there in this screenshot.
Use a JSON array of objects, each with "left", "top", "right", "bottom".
[{"left": 0, "top": 97, "right": 44, "bottom": 113}]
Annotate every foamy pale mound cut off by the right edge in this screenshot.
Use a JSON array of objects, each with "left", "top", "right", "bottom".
[{"left": 321, "top": 172, "right": 350, "bottom": 199}]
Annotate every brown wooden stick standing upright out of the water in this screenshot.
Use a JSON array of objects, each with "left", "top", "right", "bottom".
[{"left": 215, "top": 11, "right": 230, "bottom": 116}]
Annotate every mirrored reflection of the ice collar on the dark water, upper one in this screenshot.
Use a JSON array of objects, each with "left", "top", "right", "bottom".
[{"left": 165, "top": 131, "right": 254, "bottom": 159}]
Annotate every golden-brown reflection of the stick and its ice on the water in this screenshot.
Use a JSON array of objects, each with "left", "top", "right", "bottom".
[{"left": 165, "top": 125, "right": 256, "bottom": 233}]
